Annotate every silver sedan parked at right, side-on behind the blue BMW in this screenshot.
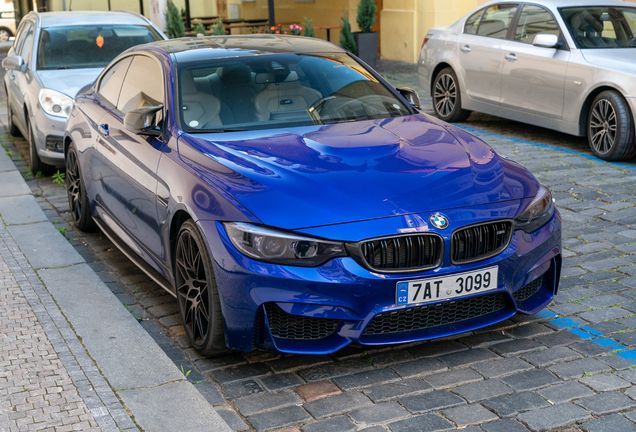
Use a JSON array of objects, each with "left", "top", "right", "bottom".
[{"left": 418, "top": 0, "right": 636, "bottom": 160}]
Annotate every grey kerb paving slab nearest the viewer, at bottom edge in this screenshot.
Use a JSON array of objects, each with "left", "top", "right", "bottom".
[{"left": 118, "top": 382, "right": 232, "bottom": 432}]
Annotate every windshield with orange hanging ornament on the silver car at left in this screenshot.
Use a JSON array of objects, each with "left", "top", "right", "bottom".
[{"left": 37, "top": 25, "right": 162, "bottom": 70}]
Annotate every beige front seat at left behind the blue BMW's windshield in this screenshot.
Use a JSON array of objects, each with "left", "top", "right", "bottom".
[{"left": 181, "top": 71, "right": 223, "bottom": 129}]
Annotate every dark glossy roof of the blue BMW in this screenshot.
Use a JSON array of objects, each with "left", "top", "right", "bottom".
[{"left": 132, "top": 34, "right": 345, "bottom": 62}]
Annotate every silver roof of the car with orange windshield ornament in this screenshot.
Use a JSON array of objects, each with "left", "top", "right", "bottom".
[{"left": 34, "top": 11, "right": 153, "bottom": 27}]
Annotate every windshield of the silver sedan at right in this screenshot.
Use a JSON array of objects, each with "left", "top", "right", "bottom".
[{"left": 559, "top": 6, "right": 636, "bottom": 49}]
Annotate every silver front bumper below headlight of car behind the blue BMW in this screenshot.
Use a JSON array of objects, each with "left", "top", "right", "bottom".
[{"left": 30, "top": 108, "right": 66, "bottom": 166}]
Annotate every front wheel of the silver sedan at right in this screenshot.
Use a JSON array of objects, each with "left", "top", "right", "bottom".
[{"left": 587, "top": 90, "right": 636, "bottom": 161}]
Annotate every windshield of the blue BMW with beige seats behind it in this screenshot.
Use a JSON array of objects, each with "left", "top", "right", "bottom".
[{"left": 179, "top": 54, "right": 413, "bottom": 133}]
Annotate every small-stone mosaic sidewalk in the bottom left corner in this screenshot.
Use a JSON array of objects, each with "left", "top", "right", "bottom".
[{"left": 0, "top": 221, "right": 139, "bottom": 432}]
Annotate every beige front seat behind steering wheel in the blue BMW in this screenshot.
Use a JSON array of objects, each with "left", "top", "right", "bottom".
[{"left": 254, "top": 71, "right": 322, "bottom": 121}]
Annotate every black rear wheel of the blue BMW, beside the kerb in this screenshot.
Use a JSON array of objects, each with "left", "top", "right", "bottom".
[{"left": 64, "top": 144, "right": 97, "bottom": 231}]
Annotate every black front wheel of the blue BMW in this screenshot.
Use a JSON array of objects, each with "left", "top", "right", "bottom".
[{"left": 174, "top": 220, "right": 228, "bottom": 356}]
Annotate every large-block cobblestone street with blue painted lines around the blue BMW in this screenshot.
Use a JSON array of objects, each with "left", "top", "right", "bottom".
[{"left": 7, "top": 63, "right": 636, "bottom": 432}]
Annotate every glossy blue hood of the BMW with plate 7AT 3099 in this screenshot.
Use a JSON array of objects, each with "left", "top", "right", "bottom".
[{"left": 179, "top": 114, "right": 538, "bottom": 229}]
